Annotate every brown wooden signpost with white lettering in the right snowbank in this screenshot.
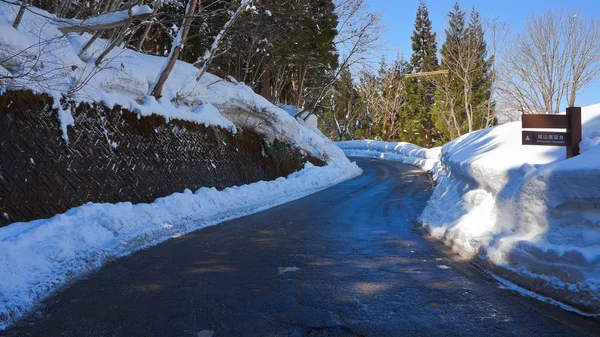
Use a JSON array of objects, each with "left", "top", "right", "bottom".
[{"left": 521, "top": 107, "right": 582, "bottom": 159}]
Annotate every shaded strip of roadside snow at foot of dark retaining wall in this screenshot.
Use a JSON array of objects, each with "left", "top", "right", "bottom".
[{"left": 0, "top": 163, "right": 362, "bottom": 330}]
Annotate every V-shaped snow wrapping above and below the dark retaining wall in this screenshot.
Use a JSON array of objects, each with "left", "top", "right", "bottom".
[{"left": 0, "top": 2, "right": 361, "bottom": 330}]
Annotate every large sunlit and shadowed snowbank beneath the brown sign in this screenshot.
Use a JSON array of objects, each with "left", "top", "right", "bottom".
[{"left": 420, "top": 105, "right": 600, "bottom": 313}]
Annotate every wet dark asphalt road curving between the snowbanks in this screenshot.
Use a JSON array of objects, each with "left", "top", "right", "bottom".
[{"left": 0, "top": 159, "right": 600, "bottom": 337}]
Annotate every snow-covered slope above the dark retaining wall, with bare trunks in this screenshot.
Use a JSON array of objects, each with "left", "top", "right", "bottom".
[{"left": 0, "top": 2, "right": 349, "bottom": 165}]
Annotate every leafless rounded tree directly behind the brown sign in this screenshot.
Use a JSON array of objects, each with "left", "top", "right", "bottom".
[{"left": 501, "top": 10, "right": 600, "bottom": 113}]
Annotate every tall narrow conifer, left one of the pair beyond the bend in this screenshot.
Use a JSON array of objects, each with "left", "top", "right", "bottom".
[{"left": 402, "top": 0, "right": 438, "bottom": 147}]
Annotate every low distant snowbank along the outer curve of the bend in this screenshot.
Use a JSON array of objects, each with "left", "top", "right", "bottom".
[{"left": 336, "top": 140, "right": 443, "bottom": 180}]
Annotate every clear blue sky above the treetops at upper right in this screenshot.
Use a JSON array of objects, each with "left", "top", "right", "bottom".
[{"left": 368, "top": 0, "right": 600, "bottom": 106}]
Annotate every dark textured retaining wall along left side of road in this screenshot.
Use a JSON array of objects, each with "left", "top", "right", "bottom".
[{"left": 0, "top": 91, "right": 324, "bottom": 226}]
